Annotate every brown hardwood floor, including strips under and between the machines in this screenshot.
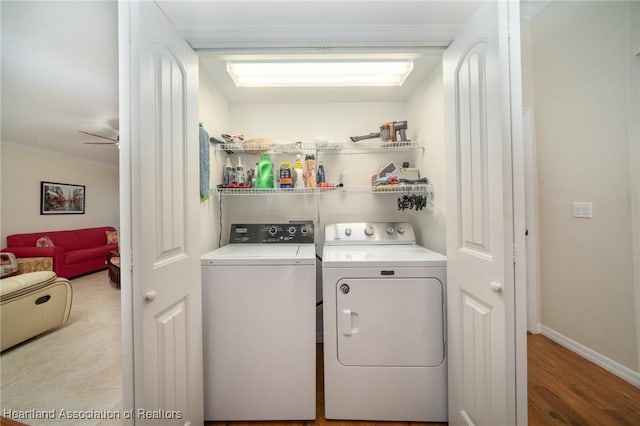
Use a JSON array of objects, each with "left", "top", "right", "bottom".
[{"left": 206, "top": 334, "right": 640, "bottom": 426}]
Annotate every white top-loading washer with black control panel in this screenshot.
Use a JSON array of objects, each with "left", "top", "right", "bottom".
[{"left": 201, "top": 224, "right": 316, "bottom": 421}]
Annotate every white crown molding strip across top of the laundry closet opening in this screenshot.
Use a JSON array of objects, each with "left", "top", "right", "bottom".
[{"left": 178, "top": 25, "right": 462, "bottom": 51}]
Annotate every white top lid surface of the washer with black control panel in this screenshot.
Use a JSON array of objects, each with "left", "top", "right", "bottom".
[{"left": 200, "top": 244, "right": 316, "bottom": 265}]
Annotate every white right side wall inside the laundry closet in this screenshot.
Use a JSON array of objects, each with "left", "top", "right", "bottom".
[{"left": 407, "top": 66, "right": 447, "bottom": 254}]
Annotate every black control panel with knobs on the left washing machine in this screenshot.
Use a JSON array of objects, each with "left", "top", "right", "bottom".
[{"left": 229, "top": 223, "right": 314, "bottom": 244}]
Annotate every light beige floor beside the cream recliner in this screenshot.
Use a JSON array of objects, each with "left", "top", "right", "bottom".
[{"left": 0, "top": 271, "right": 122, "bottom": 426}]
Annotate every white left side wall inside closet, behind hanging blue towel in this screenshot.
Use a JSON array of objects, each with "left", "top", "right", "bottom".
[{"left": 198, "top": 73, "right": 229, "bottom": 253}]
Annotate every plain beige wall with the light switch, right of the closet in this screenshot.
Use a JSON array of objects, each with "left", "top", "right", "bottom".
[{"left": 525, "top": 2, "right": 640, "bottom": 372}]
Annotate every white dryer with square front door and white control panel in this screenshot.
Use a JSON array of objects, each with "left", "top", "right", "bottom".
[{"left": 322, "top": 223, "right": 447, "bottom": 422}]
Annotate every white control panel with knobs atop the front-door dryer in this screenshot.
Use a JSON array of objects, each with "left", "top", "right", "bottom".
[{"left": 324, "top": 222, "right": 416, "bottom": 245}]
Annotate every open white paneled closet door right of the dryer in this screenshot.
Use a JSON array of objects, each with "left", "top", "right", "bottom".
[{"left": 443, "top": 1, "right": 521, "bottom": 425}]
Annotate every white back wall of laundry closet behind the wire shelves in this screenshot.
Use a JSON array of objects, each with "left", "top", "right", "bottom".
[{"left": 223, "top": 103, "right": 416, "bottom": 247}]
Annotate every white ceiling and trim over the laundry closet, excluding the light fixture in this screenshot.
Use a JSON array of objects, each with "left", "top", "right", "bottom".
[{"left": 158, "top": 0, "right": 475, "bottom": 103}]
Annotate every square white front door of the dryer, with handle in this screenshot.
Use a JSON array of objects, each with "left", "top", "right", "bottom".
[{"left": 336, "top": 278, "right": 444, "bottom": 367}]
